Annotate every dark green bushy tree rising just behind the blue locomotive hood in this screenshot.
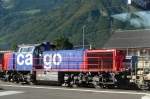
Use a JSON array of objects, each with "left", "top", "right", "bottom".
[{"left": 54, "top": 36, "right": 73, "bottom": 50}]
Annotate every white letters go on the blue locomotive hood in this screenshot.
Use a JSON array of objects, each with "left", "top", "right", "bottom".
[{"left": 43, "top": 54, "right": 62, "bottom": 69}]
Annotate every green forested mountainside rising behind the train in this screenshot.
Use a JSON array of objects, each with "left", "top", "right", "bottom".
[{"left": 0, "top": 0, "right": 139, "bottom": 49}]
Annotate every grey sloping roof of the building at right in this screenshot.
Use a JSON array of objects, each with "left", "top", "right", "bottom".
[{"left": 103, "top": 29, "right": 150, "bottom": 48}]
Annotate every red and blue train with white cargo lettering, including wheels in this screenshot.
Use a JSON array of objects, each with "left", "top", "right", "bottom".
[{"left": 0, "top": 43, "right": 150, "bottom": 88}]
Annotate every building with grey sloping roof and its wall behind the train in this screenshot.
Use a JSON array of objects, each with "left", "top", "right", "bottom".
[{"left": 103, "top": 30, "right": 150, "bottom": 57}]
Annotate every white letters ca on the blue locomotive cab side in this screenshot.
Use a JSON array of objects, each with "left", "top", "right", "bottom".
[{"left": 17, "top": 54, "right": 33, "bottom": 65}]
